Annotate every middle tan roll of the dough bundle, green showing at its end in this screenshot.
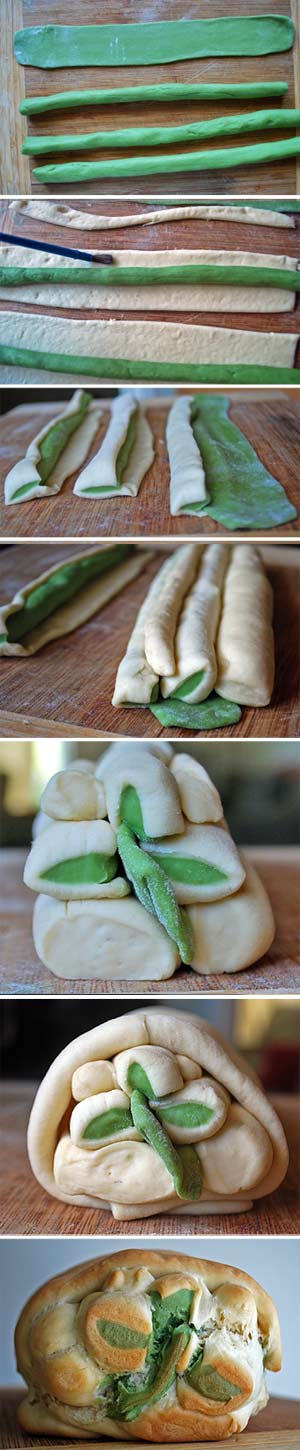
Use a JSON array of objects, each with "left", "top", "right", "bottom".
[{"left": 161, "top": 544, "right": 229, "bottom": 703}]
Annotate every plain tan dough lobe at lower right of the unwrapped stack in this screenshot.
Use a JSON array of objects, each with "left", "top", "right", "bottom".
[{"left": 188, "top": 857, "right": 275, "bottom": 976}]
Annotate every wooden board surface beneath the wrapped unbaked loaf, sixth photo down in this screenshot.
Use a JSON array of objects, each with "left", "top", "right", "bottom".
[{"left": 0, "top": 1082, "right": 300, "bottom": 1237}]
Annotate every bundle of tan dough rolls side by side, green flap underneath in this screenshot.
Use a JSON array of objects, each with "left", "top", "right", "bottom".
[{"left": 113, "top": 542, "right": 274, "bottom": 705}]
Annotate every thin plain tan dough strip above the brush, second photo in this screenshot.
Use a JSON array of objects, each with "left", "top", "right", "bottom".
[{"left": 9, "top": 197, "right": 294, "bottom": 232}]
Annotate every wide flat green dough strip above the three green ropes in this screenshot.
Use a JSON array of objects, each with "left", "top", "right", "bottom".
[{"left": 14, "top": 13, "right": 294, "bottom": 70}]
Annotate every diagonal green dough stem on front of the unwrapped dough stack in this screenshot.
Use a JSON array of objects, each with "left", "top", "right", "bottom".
[{"left": 117, "top": 824, "right": 194, "bottom": 966}]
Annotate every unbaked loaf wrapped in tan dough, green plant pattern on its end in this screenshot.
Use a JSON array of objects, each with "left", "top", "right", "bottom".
[{"left": 28, "top": 1008, "right": 288, "bottom": 1219}]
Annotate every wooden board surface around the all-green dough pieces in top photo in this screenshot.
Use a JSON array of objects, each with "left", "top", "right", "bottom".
[{"left": 1, "top": 0, "right": 299, "bottom": 196}]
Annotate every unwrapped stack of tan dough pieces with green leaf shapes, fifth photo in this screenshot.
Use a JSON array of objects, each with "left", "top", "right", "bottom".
[{"left": 25, "top": 741, "right": 274, "bottom": 980}]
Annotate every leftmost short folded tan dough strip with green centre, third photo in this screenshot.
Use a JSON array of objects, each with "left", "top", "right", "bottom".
[{"left": 4, "top": 389, "right": 103, "bottom": 503}]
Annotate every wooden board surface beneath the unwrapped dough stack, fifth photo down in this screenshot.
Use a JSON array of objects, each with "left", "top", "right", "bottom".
[{"left": 0, "top": 847, "right": 299, "bottom": 998}]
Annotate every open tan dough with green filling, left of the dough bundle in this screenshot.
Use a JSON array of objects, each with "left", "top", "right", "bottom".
[{"left": 0, "top": 544, "right": 146, "bottom": 655}]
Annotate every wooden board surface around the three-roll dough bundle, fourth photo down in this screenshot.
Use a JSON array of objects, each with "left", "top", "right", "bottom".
[{"left": 0, "top": 544, "right": 300, "bottom": 740}]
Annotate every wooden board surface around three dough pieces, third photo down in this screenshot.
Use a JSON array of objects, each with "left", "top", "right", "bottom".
[{"left": 0, "top": 389, "right": 300, "bottom": 539}]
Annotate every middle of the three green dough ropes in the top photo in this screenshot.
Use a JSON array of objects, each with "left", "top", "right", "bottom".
[{"left": 22, "top": 107, "right": 300, "bottom": 157}]
